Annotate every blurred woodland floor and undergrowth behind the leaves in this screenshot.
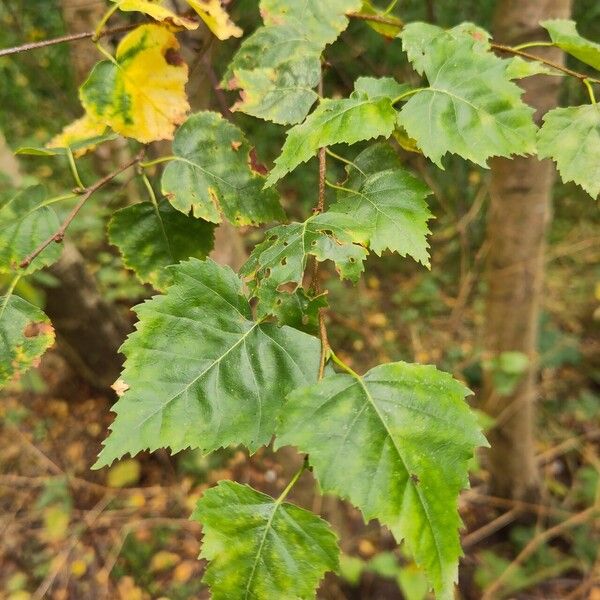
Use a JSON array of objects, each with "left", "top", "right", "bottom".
[{"left": 0, "top": 0, "right": 600, "bottom": 600}]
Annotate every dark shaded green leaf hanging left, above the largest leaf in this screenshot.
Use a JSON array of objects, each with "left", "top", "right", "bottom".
[{"left": 108, "top": 201, "right": 214, "bottom": 290}]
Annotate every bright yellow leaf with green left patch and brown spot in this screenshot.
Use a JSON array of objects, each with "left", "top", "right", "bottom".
[{"left": 80, "top": 25, "right": 190, "bottom": 143}]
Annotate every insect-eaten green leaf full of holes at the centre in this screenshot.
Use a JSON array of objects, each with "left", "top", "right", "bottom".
[{"left": 241, "top": 213, "right": 367, "bottom": 315}]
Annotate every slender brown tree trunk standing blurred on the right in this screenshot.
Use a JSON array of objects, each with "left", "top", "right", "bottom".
[{"left": 483, "top": 0, "right": 571, "bottom": 498}]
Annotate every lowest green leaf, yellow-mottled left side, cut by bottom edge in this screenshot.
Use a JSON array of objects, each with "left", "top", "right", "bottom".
[{"left": 192, "top": 481, "right": 339, "bottom": 600}]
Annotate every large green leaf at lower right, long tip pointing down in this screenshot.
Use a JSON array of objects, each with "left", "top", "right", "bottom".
[{"left": 276, "top": 362, "right": 486, "bottom": 599}]
